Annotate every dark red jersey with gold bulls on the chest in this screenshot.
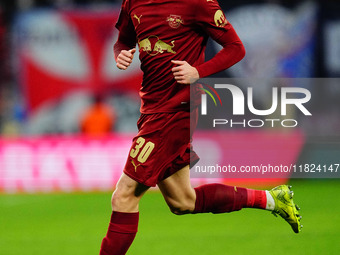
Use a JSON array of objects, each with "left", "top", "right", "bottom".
[{"left": 116, "top": 0, "right": 243, "bottom": 114}]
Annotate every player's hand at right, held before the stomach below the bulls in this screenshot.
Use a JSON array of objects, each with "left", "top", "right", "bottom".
[{"left": 171, "top": 60, "right": 200, "bottom": 84}]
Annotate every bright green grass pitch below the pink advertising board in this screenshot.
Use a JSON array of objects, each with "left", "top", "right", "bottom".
[{"left": 0, "top": 180, "right": 340, "bottom": 255}]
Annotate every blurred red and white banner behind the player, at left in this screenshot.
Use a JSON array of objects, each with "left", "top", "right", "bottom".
[{"left": 14, "top": 9, "right": 141, "bottom": 110}]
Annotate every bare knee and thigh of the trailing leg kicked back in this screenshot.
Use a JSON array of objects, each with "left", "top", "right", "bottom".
[{"left": 158, "top": 166, "right": 196, "bottom": 214}]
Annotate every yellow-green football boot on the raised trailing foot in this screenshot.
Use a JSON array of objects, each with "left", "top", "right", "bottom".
[{"left": 269, "top": 185, "right": 303, "bottom": 233}]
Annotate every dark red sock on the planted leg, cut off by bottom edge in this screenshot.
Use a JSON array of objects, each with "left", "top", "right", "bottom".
[{"left": 99, "top": 212, "right": 139, "bottom": 255}]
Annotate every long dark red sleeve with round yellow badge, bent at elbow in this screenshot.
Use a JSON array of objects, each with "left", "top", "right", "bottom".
[{"left": 196, "top": 0, "right": 245, "bottom": 78}]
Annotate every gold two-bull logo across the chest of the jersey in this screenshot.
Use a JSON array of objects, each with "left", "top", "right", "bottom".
[{"left": 138, "top": 35, "right": 176, "bottom": 56}]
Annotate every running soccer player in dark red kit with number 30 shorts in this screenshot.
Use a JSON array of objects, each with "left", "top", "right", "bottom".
[{"left": 100, "top": 0, "right": 301, "bottom": 255}]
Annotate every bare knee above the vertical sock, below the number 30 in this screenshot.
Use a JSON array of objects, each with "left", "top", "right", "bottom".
[{"left": 111, "top": 173, "right": 149, "bottom": 212}]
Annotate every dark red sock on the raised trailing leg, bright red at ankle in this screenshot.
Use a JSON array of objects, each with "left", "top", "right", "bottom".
[{"left": 193, "top": 184, "right": 267, "bottom": 213}]
